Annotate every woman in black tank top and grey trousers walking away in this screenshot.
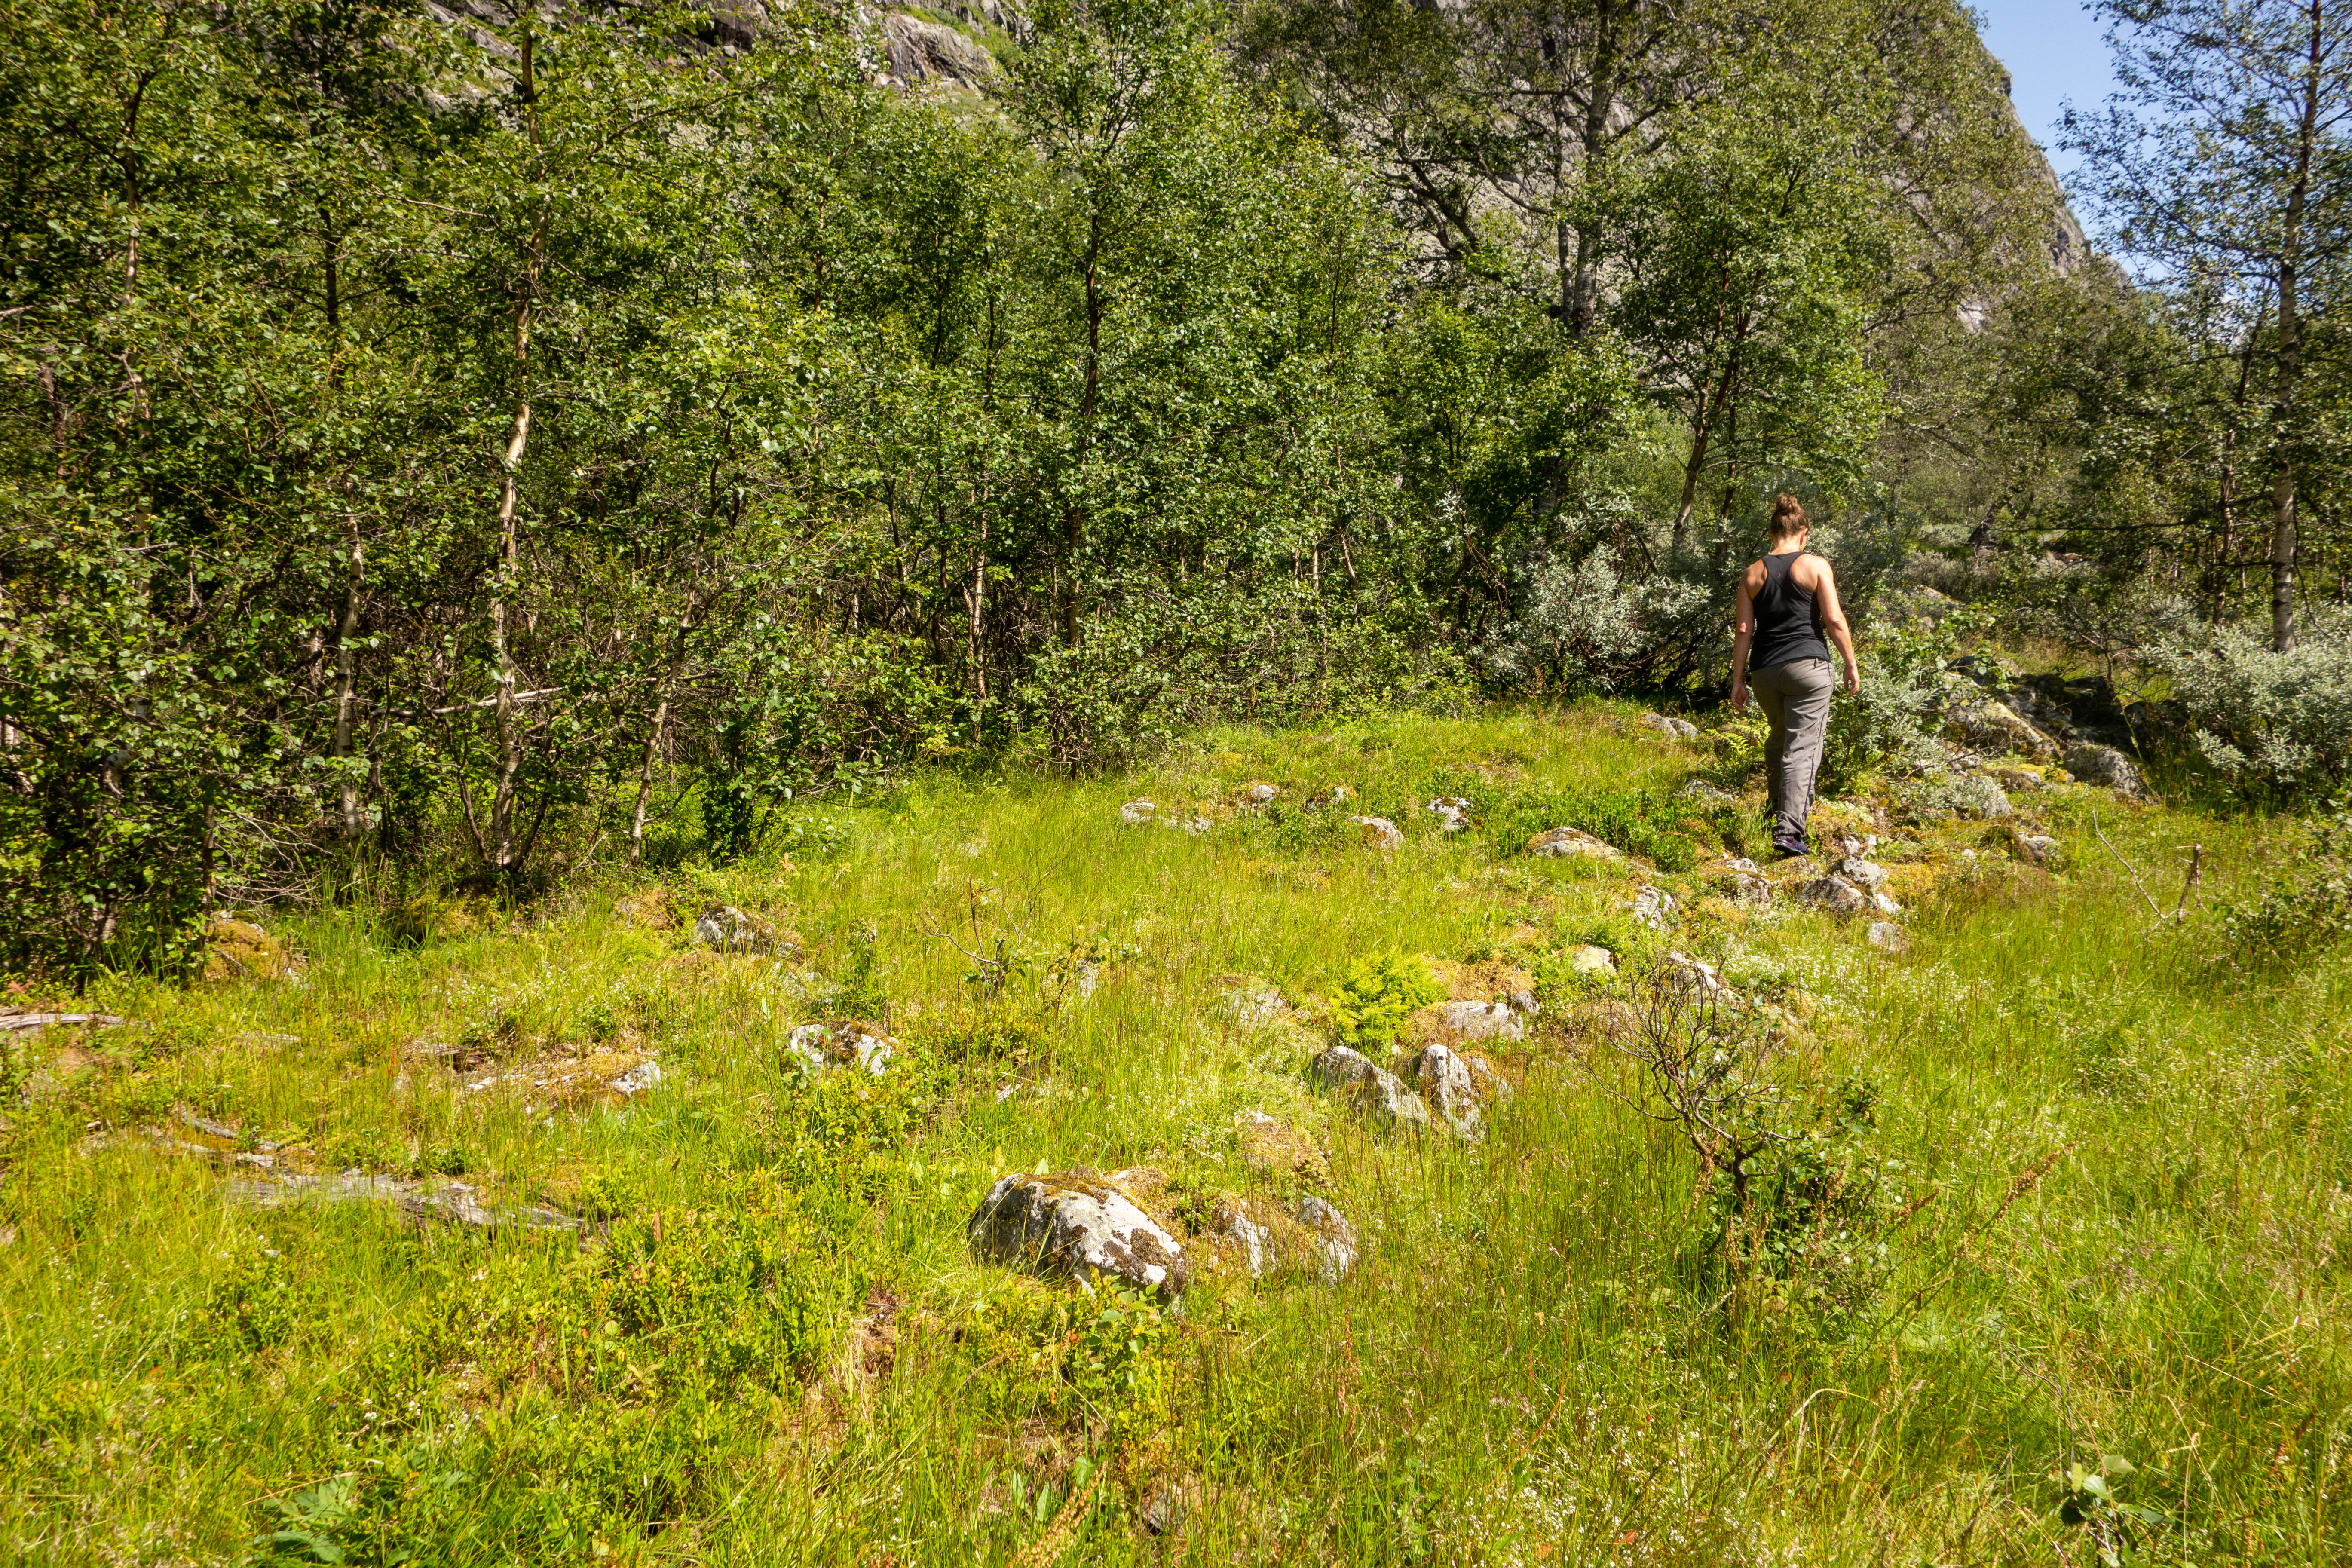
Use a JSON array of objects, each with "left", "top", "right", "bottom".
[{"left": 1731, "top": 496, "right": 1863, "bottom": 856}]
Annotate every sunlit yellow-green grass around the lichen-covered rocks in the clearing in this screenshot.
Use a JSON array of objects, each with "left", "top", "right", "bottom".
[{"left": 0, "top": 707, "right": 2352, "bottom": 1563}]
